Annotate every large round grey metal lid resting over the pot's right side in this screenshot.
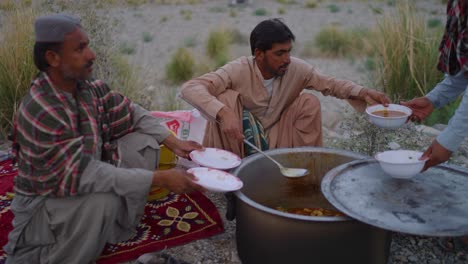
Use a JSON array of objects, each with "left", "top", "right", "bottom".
[{"left": 321, "top": 159, "right": 468, "bottom": 236}]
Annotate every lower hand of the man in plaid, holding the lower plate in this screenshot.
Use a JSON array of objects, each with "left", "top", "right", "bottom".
[{"left": 152, "top": 168, "right": 206, "bottom": 193}]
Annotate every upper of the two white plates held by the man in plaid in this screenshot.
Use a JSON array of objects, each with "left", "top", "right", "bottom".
[{"left": 190, "top": 148, "right": 241, "bottom": 170}]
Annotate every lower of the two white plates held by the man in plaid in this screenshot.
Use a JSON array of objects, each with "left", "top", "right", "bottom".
[{"left": 187, "top": 167, "right": 244, "bottom": 192}]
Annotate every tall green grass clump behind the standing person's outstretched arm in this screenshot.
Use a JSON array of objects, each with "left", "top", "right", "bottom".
[{"left": 373, "top": 1, "right": 457, "bottom": 124}]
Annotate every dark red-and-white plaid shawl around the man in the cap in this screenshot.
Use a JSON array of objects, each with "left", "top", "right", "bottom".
[{"left": 13, "top": 73, "right": 133, "bottom": 197}]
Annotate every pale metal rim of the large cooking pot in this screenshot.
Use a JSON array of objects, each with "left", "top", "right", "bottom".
[{"left": 231, "top": 147, "right": 369, "bottom": 222}]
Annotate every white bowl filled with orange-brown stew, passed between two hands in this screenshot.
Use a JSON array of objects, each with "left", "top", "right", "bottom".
[{"left": 366, "top": 104, "right": 412, "bottom": 128}]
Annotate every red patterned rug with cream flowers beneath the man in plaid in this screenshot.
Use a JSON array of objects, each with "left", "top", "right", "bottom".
[{"left": 0, "top": 160, "right": 224, "bottom": 264}]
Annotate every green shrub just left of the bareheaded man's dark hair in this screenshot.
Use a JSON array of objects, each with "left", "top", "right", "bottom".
[{"left": 206, "top": 28, "right": 232, "bottom": 66}]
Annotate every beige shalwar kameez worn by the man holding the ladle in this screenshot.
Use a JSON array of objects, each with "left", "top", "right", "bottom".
[{"left": 181, "top": 57, "right": 365, "bottom": 157}]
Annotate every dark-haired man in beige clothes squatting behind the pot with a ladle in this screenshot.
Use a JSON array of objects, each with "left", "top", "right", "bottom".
[{"left": 181, "top": 19, "right": 390, "bottom": 157}]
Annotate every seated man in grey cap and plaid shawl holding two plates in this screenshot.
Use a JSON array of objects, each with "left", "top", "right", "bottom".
[{"left": 4, "top": 14, "right": 204, "bottom": 263}]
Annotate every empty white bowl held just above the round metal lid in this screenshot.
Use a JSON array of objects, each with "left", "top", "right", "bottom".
[{"left": 375, "top": 150, "right": 426, "bottom": 179}]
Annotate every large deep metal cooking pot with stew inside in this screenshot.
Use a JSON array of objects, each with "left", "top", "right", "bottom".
[{"left": 232, "top": 147, "right": 391, "bottom": 264}]
